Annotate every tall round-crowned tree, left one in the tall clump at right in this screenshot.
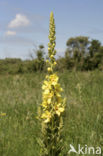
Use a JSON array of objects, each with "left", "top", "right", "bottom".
[{"left": 65, "top": 36, "right": 90, "bottom": 69}]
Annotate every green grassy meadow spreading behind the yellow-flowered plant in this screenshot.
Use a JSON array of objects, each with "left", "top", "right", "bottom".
[{"left": 0, "top": 71, "right": 103, "bottom": 156}]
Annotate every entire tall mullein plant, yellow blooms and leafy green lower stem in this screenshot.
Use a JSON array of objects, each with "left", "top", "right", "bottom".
[{"left": 39, "top": 12, "right": 65, "bottom": 156}]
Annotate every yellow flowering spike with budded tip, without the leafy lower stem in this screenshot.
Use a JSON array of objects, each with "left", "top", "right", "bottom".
[{"left": 42, "top": 13, "right": 64, "bottom": 123}]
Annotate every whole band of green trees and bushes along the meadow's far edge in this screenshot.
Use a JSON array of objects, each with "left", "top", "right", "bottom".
[{"left": 0, "top": 36, "right": 103, "bottom": 74}]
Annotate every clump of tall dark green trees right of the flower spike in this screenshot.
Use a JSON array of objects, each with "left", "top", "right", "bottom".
[{"left": 65, "top": 36, "right": 103, "bottom": 70}]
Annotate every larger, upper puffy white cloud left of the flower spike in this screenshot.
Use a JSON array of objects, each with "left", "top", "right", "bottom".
[{"left": 8, "top": 14, "right": 30, "bottom": 28}]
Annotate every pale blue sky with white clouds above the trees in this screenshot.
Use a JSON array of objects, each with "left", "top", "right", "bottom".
[{"left": 0, "top": 0, "right": 103, "bottom": 59}]
